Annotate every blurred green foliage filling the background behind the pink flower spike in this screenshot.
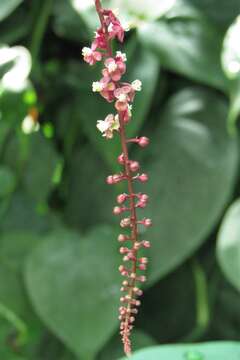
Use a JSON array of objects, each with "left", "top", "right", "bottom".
[{"left": 0, "top": 0, "right": 240, "bottom": 360}]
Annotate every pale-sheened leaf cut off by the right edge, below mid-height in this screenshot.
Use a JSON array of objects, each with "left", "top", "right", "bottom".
[{"left": 217, "top": 199, "right": 240, "bottom": 291}]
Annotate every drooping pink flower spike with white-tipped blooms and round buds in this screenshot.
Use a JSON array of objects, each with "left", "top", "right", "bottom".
[{"left": 82, "top": 0, "right": 152, "bottom": 355}]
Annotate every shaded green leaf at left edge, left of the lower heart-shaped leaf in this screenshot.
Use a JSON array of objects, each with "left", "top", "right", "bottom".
[{"left": 0, "top": 230, "right": 42, "bottom": 350}]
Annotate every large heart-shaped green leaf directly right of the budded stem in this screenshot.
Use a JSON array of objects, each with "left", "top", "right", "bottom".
[{"left": 138, "top": 88, "right": 238, "bottom": 281}]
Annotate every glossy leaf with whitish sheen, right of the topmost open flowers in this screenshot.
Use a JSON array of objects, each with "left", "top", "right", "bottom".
[{"left": 138, "top": 15, "right": 226, "bottom": 90}]
